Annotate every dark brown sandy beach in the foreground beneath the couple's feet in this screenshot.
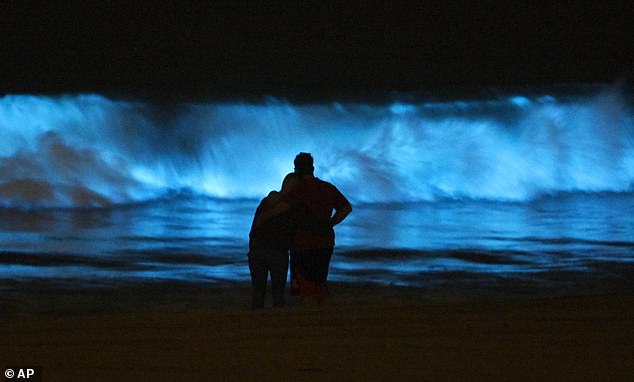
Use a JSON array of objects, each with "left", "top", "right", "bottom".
[{"left": 0, "top": 284, "right": 634, "bottom": 381}]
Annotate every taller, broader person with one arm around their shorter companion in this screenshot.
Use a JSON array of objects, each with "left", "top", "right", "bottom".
[{"left": 257, "top": 153, "right": 352, "bottom": 304}]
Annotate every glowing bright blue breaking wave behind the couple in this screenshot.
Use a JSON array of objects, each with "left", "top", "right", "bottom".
[{"left": 0, "top": 91, "right": 634, "bottom": 207}]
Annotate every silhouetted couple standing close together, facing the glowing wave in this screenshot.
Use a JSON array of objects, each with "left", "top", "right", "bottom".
[{"left": 249, "top": 152, "right": 352, "bottom": 309}]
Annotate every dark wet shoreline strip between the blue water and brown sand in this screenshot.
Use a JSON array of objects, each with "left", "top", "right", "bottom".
[{"left": 0, "top": 275, "right": 634, "bottom": 322}]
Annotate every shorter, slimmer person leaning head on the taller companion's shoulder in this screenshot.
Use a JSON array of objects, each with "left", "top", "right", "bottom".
[{"left": 249, "top": 173, "right": 299, "bottom": 309}]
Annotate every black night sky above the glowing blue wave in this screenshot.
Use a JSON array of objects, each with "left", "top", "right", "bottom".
[{"left": 0, "top": 1, "right": 634, "bottom": 99}]
